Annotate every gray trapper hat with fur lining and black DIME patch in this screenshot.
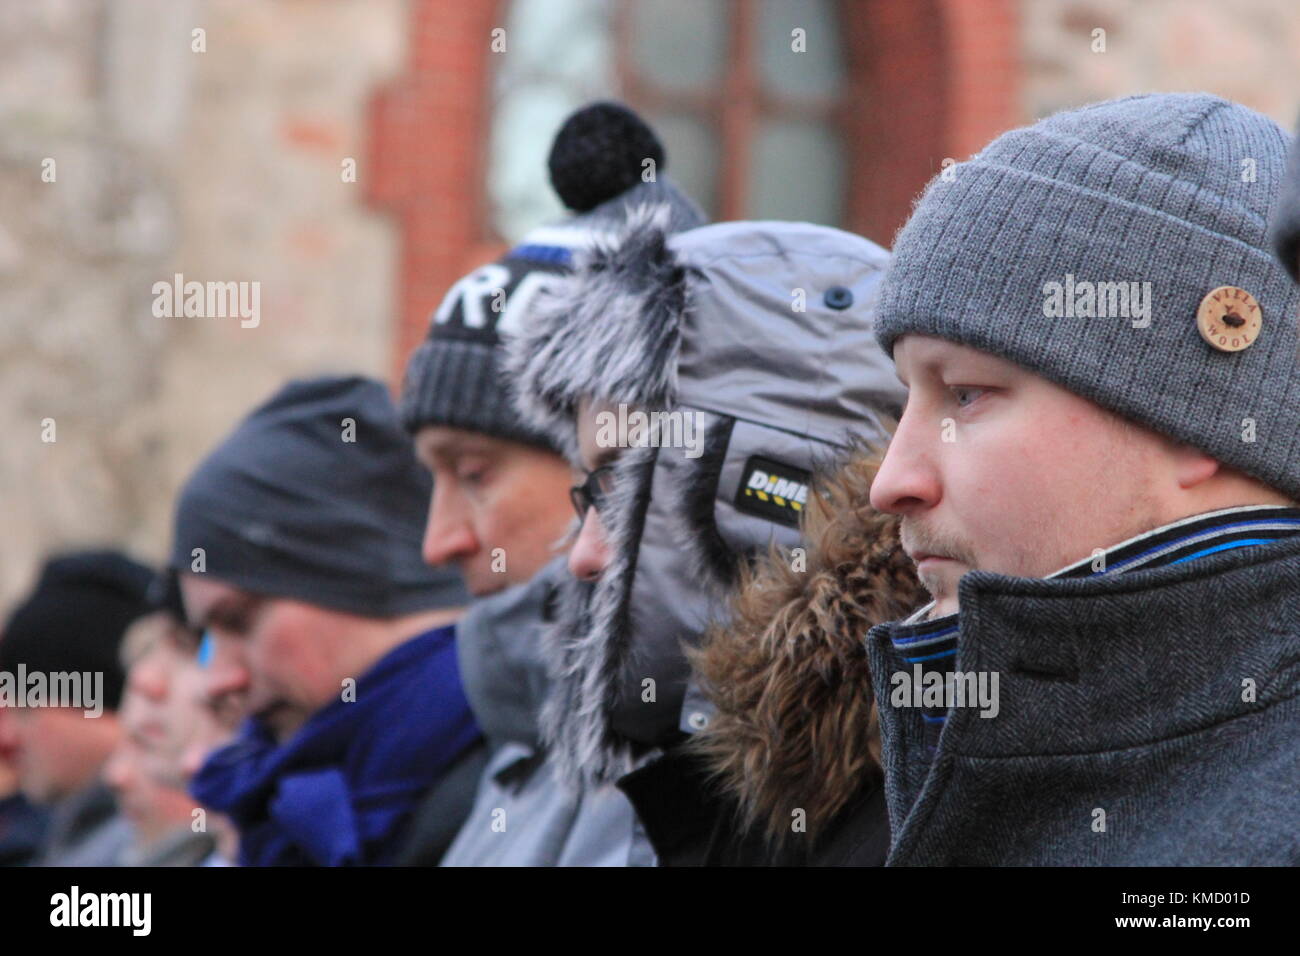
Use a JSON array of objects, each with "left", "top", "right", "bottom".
[{"left": 508, "top": 207, "right": 906, "bottom": 783}]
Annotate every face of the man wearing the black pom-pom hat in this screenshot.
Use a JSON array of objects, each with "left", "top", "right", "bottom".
[{"left": 415, "top": 425, "right": 572, "bottom": 596}]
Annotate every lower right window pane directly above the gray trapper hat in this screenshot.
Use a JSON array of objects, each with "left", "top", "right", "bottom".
[{"left": 746, "top": 120, "right": 844, "bottom": 226}]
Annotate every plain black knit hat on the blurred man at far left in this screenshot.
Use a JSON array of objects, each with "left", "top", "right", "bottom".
[{"left": 0, "top": 551, "right": 153, "bottom": 710}]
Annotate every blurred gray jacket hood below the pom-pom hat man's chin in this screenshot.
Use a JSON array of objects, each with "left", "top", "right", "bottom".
[{"left": 456, "top": 557, "right": 568, "bottom": 748}]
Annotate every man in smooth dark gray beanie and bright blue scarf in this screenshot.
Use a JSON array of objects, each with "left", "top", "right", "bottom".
[{"left": 172, "top": 377, "right": 482, "bottom": 866}]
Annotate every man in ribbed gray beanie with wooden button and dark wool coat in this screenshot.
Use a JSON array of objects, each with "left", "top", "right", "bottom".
[{"left": 867, "top": 94, "right": 1300, "bottom": 865}]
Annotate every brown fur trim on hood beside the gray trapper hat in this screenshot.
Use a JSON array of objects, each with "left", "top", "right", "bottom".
[{"left": 690, "top": 449, "right": 926, "bottom": 845}]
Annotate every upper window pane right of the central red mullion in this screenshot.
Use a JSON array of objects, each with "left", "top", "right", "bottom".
[{"left": 758, "top": 0, "right": 844, "bottom": 99}]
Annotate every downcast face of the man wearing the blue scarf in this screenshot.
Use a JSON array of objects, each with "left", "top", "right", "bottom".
[{"left": 181, "top": 572, "right": 373, "bottom": 740}]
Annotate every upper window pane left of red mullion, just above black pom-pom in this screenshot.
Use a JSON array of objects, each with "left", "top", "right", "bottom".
[{"left": 628, "top": 0, "right": 728, "bottom": 92}]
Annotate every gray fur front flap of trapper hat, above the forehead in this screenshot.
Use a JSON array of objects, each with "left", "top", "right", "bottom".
[{"left": 507, "top": 204, "right": 689, "bottom": 463}]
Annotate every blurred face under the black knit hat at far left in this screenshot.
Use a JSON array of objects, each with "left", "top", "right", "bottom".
[{"left": 0, "top": 708, "right": 118, "bottom": 804}]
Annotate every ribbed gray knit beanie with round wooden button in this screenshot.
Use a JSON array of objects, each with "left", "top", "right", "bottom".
[{"left": 876, "top": 94, "right": 1300, "bottom": 498}]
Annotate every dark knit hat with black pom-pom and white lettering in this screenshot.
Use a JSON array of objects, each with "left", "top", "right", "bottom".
[{"left": 400, "top": 103, "right": 705, "bottom": 450}]
